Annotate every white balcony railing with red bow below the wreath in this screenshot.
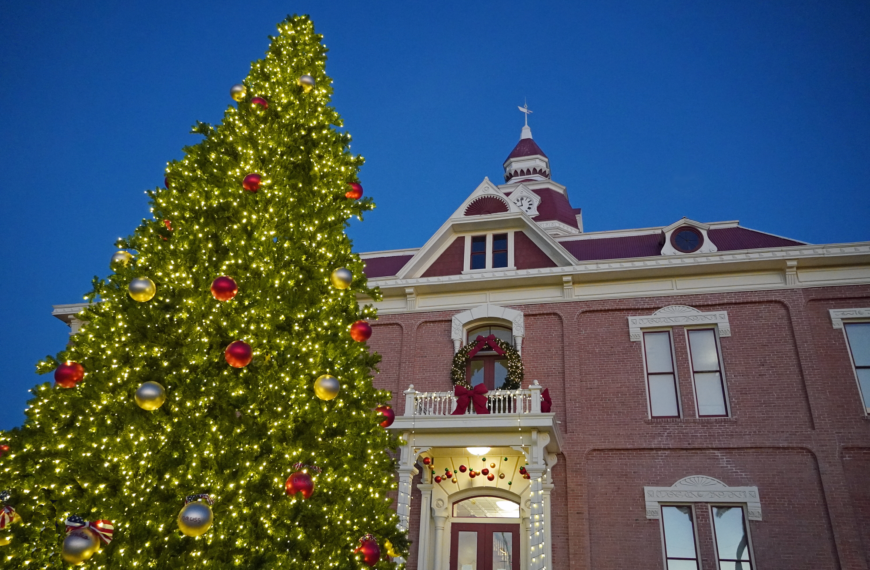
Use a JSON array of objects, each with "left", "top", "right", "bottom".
[{"left": 405, "top": 380, "right": 543, "bottom": 416}]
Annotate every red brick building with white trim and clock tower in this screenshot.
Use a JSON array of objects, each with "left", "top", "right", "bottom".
[{"left": 354, "top": 117, "right": 870, "bottom": 570}]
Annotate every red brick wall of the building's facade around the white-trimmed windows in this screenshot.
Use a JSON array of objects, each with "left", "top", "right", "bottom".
[{"left": 370, "top": 286, "right": 870, "bottom": 570}]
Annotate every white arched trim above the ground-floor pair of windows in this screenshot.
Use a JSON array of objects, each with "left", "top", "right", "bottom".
[{"left": 643, "top": 475, "right": 761, "bottom": 521}]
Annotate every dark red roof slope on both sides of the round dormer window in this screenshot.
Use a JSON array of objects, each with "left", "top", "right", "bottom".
[{"left": 559, "top": 227, "right": 803, "bottom": 261}]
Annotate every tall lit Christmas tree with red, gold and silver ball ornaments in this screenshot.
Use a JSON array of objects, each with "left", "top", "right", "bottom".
[{"left": 0, "top": 16, "right": 407, "bottom": 570}]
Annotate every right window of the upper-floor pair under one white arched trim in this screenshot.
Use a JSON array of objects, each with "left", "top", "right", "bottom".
[{"left": 686, "top": 329, "right": 728, "bottom": 418}]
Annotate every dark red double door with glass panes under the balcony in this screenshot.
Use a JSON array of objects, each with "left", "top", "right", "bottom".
[{"left": 450, "top": 523, "right": 520, "bottom": 570}]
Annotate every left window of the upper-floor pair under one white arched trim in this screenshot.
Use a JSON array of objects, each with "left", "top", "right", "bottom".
[{"left": 643, "top": 331, "right": 680, "bottom": 418}]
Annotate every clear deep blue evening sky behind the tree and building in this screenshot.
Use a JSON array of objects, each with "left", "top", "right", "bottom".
[{"left": 0, "top": 0, "right": 870, "bottom": 428}]
